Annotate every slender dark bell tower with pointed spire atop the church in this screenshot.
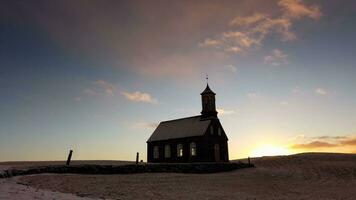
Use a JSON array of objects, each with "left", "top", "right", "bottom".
[{"left": 200, "top": 77, "right": 218, "bottom": 118}]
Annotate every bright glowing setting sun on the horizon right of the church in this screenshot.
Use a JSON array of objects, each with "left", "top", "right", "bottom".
[{"left": 251, "top": 144, "right": 290, "bottom": 157}]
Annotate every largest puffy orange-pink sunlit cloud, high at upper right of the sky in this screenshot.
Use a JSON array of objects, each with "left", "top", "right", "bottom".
[{"left": 199, "top": 0, "right": 322, "bottom": 54}]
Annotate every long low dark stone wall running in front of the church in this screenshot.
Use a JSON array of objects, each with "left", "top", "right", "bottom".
[{"left": 0, "top": 162, "right": 254, "bottom": 178}]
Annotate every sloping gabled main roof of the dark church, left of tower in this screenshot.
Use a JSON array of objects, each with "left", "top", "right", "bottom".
[{"left": 147, "top": 115, "right": 211, "bottom": 142}]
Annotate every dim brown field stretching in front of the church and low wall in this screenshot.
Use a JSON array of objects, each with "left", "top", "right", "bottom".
[{"left": 0, "top": 154, "right": 356, "bottom": 200}]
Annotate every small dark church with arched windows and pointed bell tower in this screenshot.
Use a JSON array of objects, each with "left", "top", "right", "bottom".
[{"left": 147, "top": 84, "right": 229, "bottom": 163}]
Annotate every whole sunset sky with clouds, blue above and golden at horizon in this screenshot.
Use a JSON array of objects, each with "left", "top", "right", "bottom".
[{"left": 0, "top": 0, "right": 356, "bottom": 161}]
